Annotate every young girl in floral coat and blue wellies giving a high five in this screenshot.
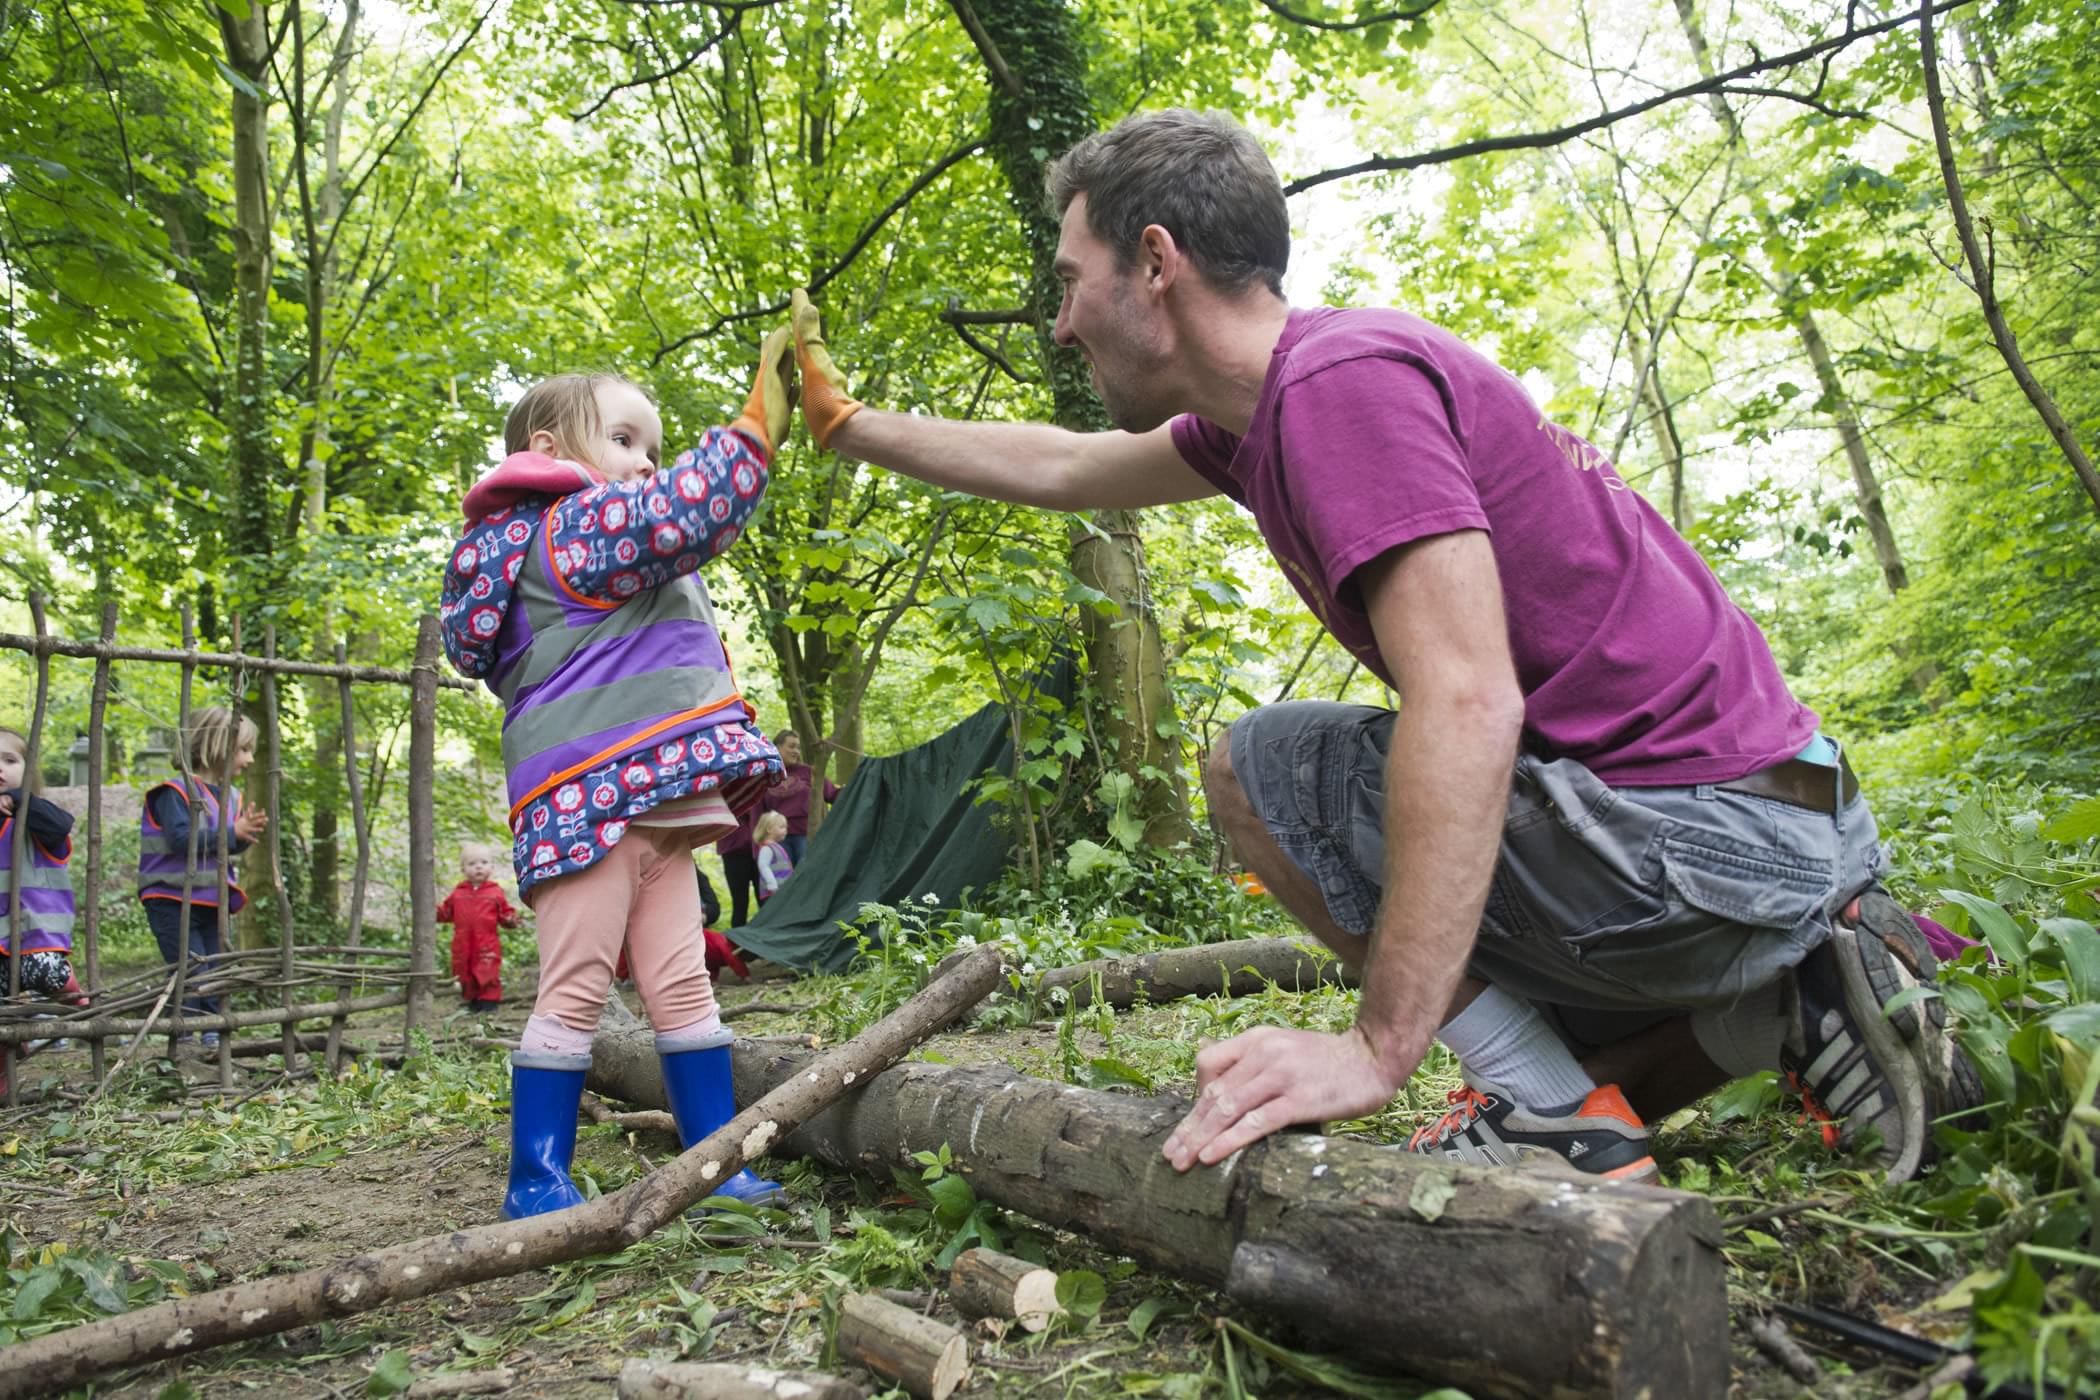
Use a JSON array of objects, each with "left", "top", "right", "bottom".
[{"left": 439, "top": 330, "right": 792, "bottom": 1219}]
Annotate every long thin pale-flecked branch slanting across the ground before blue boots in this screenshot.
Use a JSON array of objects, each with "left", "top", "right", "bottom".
[{"left": 0, "top": 949, "right": 1000, "bottom": 1400}]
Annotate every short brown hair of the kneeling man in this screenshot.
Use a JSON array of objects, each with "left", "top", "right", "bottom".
[{"left": 1044, "top": 107, "right": 1292, "bottom": 296}]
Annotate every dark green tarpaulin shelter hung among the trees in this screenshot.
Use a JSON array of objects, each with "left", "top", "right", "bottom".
[{"left": 729, "top": 663, "right": 1071, "bottom": 972}]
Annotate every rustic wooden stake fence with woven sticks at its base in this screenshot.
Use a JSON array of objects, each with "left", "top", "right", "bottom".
[{"left": 0, "top": 594, "right": 475, "bottom": 1106}]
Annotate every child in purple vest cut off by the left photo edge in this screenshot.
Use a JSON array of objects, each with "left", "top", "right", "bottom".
[{"left": 0, "top": 728, "right": 80, "bottom": 1003}]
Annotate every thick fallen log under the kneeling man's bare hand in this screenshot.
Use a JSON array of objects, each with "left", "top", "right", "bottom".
[{"left": 590, "top": 1031, "right": 1728, "bottom": 1396}]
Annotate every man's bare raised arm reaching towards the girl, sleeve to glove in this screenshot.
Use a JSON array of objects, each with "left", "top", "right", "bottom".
[{"left": 832, "top": 407, "right": 1218, "bottom": 510}]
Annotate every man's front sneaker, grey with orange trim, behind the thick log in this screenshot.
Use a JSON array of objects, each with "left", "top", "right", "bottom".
[{"left": 1407, "top": 1077, "right": 1661, "bottom": 1184}]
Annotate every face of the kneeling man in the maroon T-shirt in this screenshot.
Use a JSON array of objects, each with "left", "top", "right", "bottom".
[{"left": 1054, "top": 195, "right": 1178, "bottom": 432}]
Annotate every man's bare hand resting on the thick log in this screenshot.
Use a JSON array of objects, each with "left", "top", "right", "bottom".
[{"left": 1166, "top": 1026, "right": 1405, "bottom": 1171}]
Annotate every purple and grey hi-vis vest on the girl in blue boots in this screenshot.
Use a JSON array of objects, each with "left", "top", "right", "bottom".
[{"left": 487, "top": 514, "right": 748, "bottom": 823}]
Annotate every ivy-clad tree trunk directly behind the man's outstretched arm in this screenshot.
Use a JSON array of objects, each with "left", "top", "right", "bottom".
[{"left": 956, "top": 0, "right": 1195, "bottom": 846}]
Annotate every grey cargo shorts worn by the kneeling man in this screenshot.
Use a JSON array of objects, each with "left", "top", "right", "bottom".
[{"left": 1229, "top": 701, "right": 1884, "bottom": 1024}]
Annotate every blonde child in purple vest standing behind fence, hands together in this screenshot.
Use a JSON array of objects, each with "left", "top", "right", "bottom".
[{"left": 139, "top": 705, "right": 269, "bottom": 1047}]
